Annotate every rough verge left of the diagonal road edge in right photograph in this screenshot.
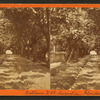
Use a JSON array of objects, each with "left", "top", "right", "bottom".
[{"left": 50, "top": 56, "right": 89, "bottom": 89}]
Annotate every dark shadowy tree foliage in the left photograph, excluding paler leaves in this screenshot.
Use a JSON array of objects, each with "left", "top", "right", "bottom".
[{"left": 1, "top": 8, "right": 50, "bottom": 66}]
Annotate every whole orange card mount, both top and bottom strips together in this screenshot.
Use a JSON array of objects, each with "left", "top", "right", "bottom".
[{"left": 0, "top": 4, "right": 100, "bottom": 96}]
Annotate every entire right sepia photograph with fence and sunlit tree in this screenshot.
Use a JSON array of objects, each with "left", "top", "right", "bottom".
[{"left": 50, "top": 7, "right": 100, "bottom": 90}]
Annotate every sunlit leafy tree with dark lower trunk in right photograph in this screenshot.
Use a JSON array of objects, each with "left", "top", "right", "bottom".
[{"left": 51, "top": 8, "right": 96, "bottom": 61}]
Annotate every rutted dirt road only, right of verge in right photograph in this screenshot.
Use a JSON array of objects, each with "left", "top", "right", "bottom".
[{"left": 71, "top": 56, "right": 100, "bottom": 90}]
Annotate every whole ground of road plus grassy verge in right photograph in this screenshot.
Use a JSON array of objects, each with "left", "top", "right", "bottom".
[{"left": 51, "top": 55, "right": 100, "bottom": 90}]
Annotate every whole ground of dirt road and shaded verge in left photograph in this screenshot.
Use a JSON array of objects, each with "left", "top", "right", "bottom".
[{"left": 0, "top": 55, "right": 50, "bottom": 89}]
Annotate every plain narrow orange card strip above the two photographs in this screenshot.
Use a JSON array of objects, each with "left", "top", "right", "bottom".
[{"left": 0, "top": 4, "right": 100, "bottom": 8}]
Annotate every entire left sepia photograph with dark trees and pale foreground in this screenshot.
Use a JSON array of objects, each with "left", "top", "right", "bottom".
[{"left": 0, "top": 7, "right": 50, "bottom": 90}]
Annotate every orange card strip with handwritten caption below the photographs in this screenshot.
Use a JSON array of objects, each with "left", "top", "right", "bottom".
[{"left": 0, "top": 90, "right": 100, "bottom": 96}]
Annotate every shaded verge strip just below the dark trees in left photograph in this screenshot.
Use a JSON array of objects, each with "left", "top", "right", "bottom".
[{"left": 15, "top": 57, "right": 49, "bottom": 73}]
